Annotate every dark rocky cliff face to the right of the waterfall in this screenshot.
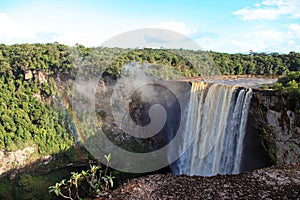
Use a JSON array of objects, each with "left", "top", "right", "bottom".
[{"left": 250, "top": 91, "right": 300, "bottom": 165}]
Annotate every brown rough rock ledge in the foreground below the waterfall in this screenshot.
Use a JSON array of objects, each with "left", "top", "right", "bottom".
[{"left": 111, "top": 163, "right": 300, "bottom": 200}]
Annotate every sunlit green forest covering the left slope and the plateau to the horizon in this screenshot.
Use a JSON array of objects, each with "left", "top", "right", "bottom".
[{"left": 0, "top": 43, "right": 300, "bottom": 198}]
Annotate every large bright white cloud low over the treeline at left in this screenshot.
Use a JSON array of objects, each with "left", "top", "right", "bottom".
[{"left": 0, "top": 7, "right": 131, "bottom": 46}]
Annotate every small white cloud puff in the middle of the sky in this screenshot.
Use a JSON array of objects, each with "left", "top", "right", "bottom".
[{"left": 149, "top": 21, "right": 195, "bottom": 36}]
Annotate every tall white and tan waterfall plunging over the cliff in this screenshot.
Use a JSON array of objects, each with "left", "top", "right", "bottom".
[{"left": 170, "top": 82, "right": 252, "bottom": 176}]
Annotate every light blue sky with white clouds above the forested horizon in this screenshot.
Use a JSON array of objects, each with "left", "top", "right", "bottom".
[{"left": 0, "top": 0, "right": 300, "bottom": 53}]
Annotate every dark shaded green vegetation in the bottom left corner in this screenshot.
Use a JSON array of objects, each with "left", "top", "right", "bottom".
[{"left": 0, "top": 147, "right": 88, "bottom": 200}]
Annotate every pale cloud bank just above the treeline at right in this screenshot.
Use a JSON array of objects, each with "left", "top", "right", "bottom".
[{"left": 196, "top": 24, "right": 300, "bottom": 53}]
